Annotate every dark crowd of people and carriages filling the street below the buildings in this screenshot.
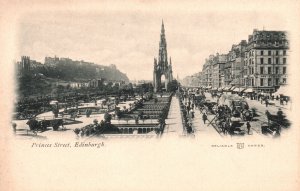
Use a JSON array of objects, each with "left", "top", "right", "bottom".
[{"left": 179, "top": 89, "right": 289, "bottom": 135}]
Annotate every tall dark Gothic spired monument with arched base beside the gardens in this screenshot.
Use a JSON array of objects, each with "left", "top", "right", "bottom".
[{"left": 153, "top": 21, "right": 173, "bottom": 92}]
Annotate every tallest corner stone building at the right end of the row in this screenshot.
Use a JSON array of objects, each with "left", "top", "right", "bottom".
[{"left": 244, "top": 30, "right": 289, "bottom": 93}]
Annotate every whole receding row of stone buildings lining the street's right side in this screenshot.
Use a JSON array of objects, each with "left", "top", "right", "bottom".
[{"left": 193, "top": 29, "right": 289, "bottom": 93}]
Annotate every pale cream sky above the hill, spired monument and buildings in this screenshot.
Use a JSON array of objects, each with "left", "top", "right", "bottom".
[{"left": 16, "top": 2, "right": 287, "bottom": 80}]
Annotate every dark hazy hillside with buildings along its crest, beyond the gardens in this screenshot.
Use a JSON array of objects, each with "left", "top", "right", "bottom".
[{"left": 17, "top": 59, "right": 129, "bottom": 97}]
